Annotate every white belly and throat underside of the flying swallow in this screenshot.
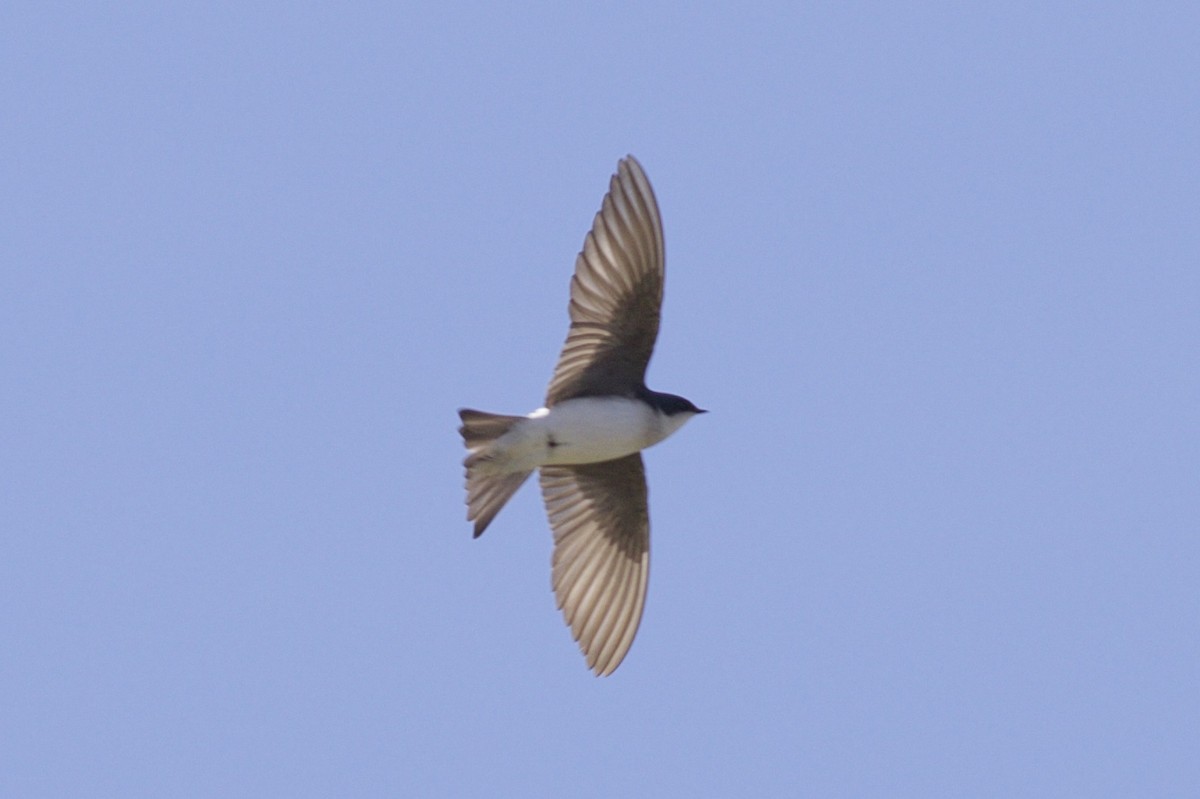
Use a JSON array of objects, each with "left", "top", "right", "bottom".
[{"left": 497, "top": 397, "right": 671, "bottom": 471}]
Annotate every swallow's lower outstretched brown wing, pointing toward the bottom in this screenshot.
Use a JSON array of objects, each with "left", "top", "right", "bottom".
[{"left": 541, "top": 452, "right": 650, "bottom": 677}]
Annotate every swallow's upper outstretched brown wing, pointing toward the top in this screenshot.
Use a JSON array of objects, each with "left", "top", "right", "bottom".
[{"left": 546, "top": 156, "right": 666, "bottom": 408}]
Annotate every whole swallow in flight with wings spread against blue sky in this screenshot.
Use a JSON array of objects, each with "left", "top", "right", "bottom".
[{"left": 458, "top": 156, "right": 704, "bottom": 677}]
